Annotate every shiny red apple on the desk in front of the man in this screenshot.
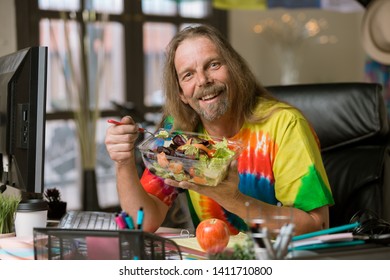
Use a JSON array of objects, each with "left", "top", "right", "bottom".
[{"left": 196, "top": 219, "right": 230, "bottom": 254}]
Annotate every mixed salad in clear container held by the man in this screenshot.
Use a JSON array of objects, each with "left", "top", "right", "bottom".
[{"left": 139, "top": 132, "right": 240, "bottom": 186}]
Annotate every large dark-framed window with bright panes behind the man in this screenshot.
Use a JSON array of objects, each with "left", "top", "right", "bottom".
[{"left": 15, "top": 0, "right": 227, "bottom": 209}]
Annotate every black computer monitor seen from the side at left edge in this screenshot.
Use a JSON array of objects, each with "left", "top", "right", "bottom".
[{"left": 0, "top": 46, "right": 47, "bottom": 197}]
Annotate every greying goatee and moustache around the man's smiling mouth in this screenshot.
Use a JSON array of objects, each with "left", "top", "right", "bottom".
[{"left": 191, "top": 84, "right": 230, "bottom": 121}]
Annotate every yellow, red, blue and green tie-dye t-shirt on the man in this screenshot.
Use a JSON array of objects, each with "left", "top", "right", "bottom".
[{"left": 141, "top": 101, "right": 334, "bottom": 234}]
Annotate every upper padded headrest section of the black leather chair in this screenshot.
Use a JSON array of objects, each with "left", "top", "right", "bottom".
[{"left": 267, "top": 83, "right": 389, "bottom": 151}]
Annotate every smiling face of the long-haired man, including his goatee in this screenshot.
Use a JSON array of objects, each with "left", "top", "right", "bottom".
[{"left": 175, "top": 37, "right": 230, "bottom": 121}]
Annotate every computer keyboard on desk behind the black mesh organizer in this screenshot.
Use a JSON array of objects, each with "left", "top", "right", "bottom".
[{"left": 58, "top": 210, "right": 118, "bottom": 230}]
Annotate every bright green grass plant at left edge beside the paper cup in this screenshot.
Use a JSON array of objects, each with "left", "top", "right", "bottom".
[{"left": 0, "top": 194, "right": 21, "bottom": 236}]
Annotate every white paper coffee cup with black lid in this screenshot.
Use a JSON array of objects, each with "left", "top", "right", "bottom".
[{"left": 15, "top": 199, "right": 48, "bottom": 237}]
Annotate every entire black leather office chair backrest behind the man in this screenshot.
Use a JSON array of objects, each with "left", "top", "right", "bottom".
[{"left": 267, "top": 83, "right": 390, "bottom": 226}]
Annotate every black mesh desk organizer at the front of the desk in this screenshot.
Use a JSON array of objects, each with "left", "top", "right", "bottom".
[{"left": 34, "top": 228, "right": 182, "bottom": 260}]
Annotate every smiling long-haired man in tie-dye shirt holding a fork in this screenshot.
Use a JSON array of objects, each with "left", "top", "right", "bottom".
[{"left": 106, "top": 26, "right": 334, "bottom": 234}]
